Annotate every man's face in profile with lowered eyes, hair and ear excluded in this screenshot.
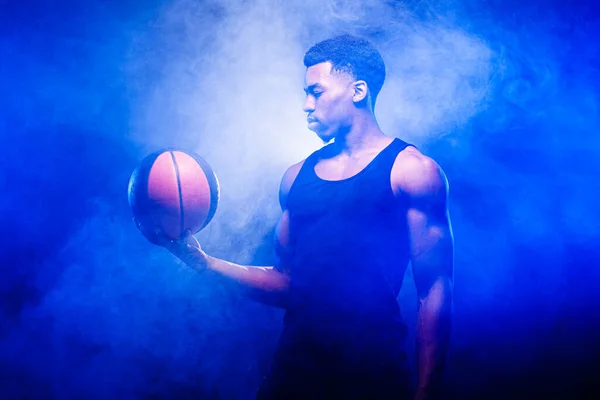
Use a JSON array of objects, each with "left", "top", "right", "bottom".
[{"left": 303, "top": 62, "right": 354, "bottom": 143}]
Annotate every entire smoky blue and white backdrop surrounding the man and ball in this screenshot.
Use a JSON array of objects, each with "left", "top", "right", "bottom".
[{"left": 0, "top": 0, "right": 600, "bottom": 399}]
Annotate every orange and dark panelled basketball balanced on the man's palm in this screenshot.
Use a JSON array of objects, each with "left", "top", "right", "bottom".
[{"left": 128, "top": 150, "right": 220, "bottom": 239}]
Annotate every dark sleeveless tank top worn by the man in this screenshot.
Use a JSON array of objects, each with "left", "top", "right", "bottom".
[{"left": 284, "top": 139, "right": 409, "bottom": 340}]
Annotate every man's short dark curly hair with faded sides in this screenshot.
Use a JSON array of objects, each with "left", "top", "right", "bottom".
[{"left": 304, "top": 35, "right": 385, "bottom": 107}]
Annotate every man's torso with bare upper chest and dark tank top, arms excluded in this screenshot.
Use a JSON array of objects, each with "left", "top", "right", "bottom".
[{"left": 258, "top": 139, "right": 418, "bottom": 398}]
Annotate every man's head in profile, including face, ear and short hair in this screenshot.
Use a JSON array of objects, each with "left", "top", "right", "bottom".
[{"left": 304, "top": 35, "right": 385, "bottom": 142}]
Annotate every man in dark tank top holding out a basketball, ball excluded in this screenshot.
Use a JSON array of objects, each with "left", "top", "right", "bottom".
[{"left": 142, "top": 35, "right": 453, "bottom": 399}]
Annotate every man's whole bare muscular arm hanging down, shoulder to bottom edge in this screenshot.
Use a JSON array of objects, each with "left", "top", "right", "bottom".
[{"left": 392, "top": 154, "right": 454, "bottom": 400}]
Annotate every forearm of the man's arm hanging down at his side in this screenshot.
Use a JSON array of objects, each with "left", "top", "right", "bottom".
[{"left": 416, "top": 281, "right": 452, "bottom": 400}]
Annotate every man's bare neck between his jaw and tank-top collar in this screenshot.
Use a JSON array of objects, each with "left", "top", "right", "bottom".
[{"left": 334, "top": 113, "right": 387, "bottom": 157}]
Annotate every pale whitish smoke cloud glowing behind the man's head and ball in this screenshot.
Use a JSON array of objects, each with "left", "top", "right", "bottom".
[{"left": 126, "top": 0, "right": 492, "bottom": 258}]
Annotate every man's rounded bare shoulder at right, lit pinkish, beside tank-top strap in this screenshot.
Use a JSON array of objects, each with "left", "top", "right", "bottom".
[{"left": 391, "top": 146, "right": 448, "bottom": 196}]
